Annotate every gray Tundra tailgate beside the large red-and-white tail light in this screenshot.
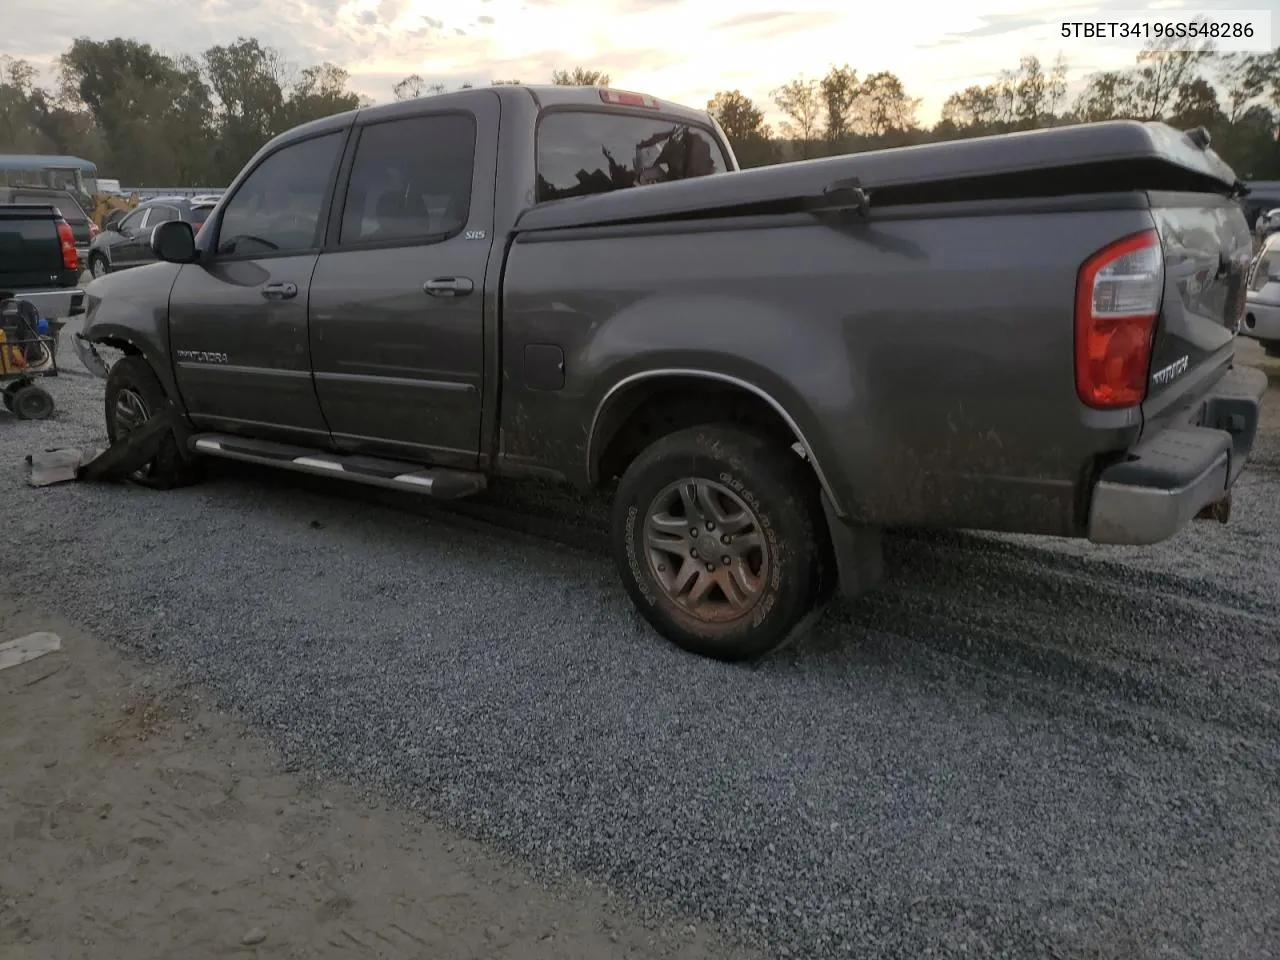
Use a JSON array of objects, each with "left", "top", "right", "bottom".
[{"left": 1143, "top": 193, "right": 1253, "bottom": 421}]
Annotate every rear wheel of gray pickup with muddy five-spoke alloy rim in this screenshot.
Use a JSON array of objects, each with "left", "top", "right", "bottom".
[{"left": 611, "top": 424, "right": 826, "bottom": 662}]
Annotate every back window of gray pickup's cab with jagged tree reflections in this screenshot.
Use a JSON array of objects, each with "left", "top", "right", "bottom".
[{"left": 538, "top": 110, "right": 728, "bottom": 202}]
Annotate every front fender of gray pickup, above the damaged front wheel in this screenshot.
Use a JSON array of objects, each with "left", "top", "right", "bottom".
[{"left": 77, "top": 262, "right": 183, "bottom": 410}]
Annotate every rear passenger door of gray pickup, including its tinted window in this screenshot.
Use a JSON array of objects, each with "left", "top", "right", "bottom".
[{"left": 310, "top": 101, "right": 498, "bottom": 467}]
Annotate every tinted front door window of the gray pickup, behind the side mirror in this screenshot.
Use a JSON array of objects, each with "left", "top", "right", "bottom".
[{"left": 216, "top": 133, "right": 342, "bottom": 256}]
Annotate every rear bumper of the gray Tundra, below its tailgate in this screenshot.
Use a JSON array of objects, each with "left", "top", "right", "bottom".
[{"left": 1089, "top": 367, "right": 1267, "bottom": 545}]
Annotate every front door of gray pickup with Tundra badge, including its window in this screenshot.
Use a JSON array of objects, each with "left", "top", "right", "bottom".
[{"left": 169, "top": 132, "right": 346, "bottom": 445}]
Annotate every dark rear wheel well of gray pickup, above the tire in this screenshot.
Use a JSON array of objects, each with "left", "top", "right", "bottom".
[{"left": 593, "top": 376, "right": 800, "bottom": 484}]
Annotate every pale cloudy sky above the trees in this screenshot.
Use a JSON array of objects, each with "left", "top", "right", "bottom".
[{"left": 0, "top": 0, "right": 1280, "bottom": 123}]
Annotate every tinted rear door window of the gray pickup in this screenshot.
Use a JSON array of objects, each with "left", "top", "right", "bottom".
[{"left": 338, "top": 114, "right": 476, "bottom": 246}]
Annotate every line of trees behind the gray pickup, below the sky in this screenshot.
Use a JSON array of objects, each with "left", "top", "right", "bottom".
[{"left": 0, "top": 37, "right": 1280, "bottom": 187}]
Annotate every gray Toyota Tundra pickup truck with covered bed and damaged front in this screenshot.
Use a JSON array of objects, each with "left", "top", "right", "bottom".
[{"left": 81, "top": 86, "right": 1266, "bottom": 659}]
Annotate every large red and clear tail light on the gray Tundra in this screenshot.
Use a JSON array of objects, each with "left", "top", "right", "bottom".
[{"left": 1075, "top": 230, "right": 1165, "bottom": 410}]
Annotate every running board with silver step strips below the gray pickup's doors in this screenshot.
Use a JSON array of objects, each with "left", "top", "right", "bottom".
[{"left": 189, "top": 434, "right": 488, "bottom": 500}]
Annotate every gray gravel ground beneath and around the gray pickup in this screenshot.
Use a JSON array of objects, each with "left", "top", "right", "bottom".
[{"left": 0, "top": 327, "right": 1280, "bottom": 959}]
